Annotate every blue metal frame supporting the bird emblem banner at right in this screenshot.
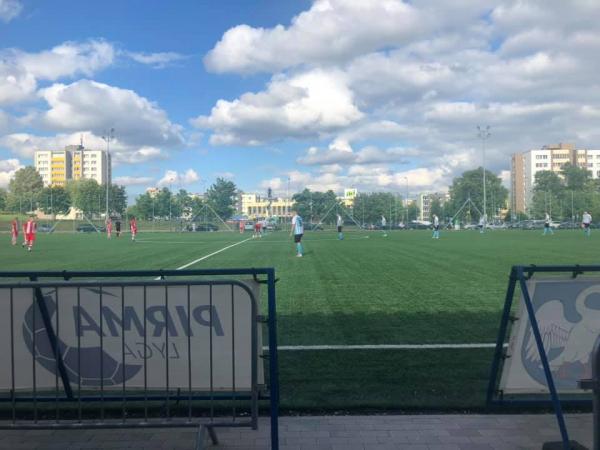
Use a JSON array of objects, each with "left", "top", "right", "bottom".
[{"left": 487, "top": 265, "right": 600, "bottom": 450}]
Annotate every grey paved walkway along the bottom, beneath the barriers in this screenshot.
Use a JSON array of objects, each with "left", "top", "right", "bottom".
[{"left": 0, "top": 414, "right": 592, "bottom": 450}]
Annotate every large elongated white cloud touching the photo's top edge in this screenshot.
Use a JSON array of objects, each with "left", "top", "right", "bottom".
[{"left": 204, "top": 0, "right": 428, "bottom": 73}]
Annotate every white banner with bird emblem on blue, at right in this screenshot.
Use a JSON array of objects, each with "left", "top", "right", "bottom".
[{"left": 500, "top": 278, "right": 600, "bottom": 394}]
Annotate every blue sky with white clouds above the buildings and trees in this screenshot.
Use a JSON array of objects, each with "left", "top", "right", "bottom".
[{"left": 0, "top": 0, "right": 600, "bottom": 196}]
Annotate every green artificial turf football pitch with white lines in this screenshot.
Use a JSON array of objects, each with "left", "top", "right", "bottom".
[{"left": 0, "top": 229, "right": 600, "bottom": 411}]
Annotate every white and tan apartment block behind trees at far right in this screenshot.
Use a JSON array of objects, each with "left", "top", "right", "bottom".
[{"left": 511, "top": 143, "right": 600, "bottom": 212}]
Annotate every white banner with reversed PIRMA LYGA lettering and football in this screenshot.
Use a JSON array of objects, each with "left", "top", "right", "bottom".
[{"left": 0, "top": 281, "right": 264, "bottom": 391}]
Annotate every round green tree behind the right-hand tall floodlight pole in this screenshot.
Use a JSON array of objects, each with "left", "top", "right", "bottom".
[{"left": 449, "top": 167, "right": 508, "bottom": 219}]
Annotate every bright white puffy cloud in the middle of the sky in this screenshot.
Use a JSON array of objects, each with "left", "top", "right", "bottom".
[{"left": 192, "top": 70, "right": 362, "bottom": 145}]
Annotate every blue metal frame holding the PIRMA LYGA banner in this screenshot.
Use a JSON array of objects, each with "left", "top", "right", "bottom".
[{"left": 0, "top": 268, "right": 279, "bottom": 450}]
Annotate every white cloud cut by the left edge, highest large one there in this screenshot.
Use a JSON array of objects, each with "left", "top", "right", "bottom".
[{"left": 0, "top": 40, "right": 115, "bottom": 104}]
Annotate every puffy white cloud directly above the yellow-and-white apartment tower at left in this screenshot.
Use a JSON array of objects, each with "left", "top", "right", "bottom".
[{"left": 37, "top": 80, "right": 184, "bottom": 147}]
